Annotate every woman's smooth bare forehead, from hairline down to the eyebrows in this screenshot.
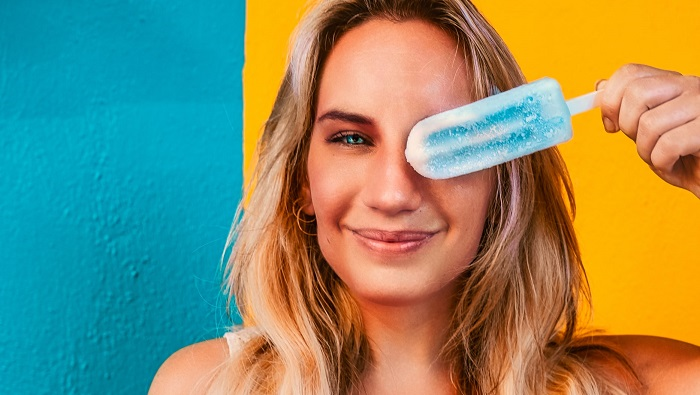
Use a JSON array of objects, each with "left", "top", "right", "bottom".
[{"left": 318, "top": 19, "right": 471, "bottom": 116}]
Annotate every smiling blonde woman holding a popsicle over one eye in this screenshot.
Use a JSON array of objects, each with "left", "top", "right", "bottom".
[{"left": 151, "top": 0, "right": 700, "bottom": 394}]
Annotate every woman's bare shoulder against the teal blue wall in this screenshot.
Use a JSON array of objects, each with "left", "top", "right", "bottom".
[{"left": 148, "top": 338, "right": 228, "bottom": 395}]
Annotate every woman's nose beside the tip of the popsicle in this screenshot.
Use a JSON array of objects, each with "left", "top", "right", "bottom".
[{"left": 363, "top": 141, "right": 424, "bottom": 215}]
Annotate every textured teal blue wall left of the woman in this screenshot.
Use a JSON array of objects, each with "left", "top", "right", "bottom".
[{"left": 0, "top": 0, "right": 245, "bottom": 394}]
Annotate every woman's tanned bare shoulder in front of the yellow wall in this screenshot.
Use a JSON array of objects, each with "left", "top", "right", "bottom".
[{"left": 600, "top": 335, "right": 700, "bottom": 394}]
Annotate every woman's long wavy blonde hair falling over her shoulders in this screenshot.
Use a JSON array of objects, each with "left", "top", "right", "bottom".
[{"left": 210, "top": 0, "right": 634, "bottom": 394}]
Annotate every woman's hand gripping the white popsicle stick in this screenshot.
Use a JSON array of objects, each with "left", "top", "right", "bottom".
[{"left": 596, "top": 64, "right": 700, "bottom": 198}]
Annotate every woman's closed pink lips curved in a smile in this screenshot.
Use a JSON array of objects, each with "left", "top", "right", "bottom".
[{"left": 350, "top": 229, "right": 437, "bottom": 253}]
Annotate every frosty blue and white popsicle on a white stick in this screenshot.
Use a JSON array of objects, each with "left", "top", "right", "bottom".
[{"left": 406, "top": 78, "right": 598, "bottom": 179}]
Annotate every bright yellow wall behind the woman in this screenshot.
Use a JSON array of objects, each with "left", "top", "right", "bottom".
[{"left": 244, "top": 0, "right": 700, "bottom": 344}]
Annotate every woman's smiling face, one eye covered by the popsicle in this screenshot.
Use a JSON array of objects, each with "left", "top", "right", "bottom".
[{"left": 304, "top": 20, "right": 495, "bottom": 306}]
